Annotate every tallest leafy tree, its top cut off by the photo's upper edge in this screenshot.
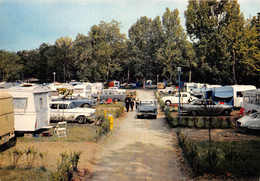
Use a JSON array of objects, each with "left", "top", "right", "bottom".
[{"left": 185, "top": 0, "right": 249, "bottom": 84}]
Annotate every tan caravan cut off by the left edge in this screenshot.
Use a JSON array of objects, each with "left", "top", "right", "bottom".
[{"left": 0, "top": 91, "right": 14, "bottom": 145}]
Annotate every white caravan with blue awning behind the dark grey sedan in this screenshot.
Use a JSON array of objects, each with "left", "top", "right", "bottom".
[{"left": 206, "top": 85, "right": 256, "bottom": 108}]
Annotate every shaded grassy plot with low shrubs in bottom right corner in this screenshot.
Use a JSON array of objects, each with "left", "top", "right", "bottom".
[{"left": 176, "top": 130, "right": 260, "bottom": 177}]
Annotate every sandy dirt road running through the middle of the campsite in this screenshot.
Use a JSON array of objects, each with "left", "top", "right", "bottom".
[{"left": 91, "top": 90, "right": 188, "bottom": 181}]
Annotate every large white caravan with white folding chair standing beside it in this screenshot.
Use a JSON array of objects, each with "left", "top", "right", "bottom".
[{"left": 6, "top": 86, "right": 50, "bottom": 132}]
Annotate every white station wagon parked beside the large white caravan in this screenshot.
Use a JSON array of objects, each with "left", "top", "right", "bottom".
[{"left": 50, "top": 101, "right": 96, "bottom": 124}]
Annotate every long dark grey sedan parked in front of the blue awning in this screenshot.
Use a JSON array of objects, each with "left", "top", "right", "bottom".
[{"left": 181, "top": 99, "right": 234, "bottom": 116}]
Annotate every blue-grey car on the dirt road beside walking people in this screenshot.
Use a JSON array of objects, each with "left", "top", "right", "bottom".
[{"left": 136, "top": 101, "right": 157, "bottom": 119}]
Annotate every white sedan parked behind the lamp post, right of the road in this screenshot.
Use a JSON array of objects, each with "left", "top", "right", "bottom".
[{"left": 162, "top": 92, "right": 198, "bottom": 106}]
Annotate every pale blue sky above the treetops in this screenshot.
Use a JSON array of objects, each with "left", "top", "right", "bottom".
[{"left": 0, "top": 0, "right": 260, "bottom": 52}]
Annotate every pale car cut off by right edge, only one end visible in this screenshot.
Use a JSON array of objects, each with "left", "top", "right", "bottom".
[{"left": 236, "top": 112, "right": 260, "bottom": 133}]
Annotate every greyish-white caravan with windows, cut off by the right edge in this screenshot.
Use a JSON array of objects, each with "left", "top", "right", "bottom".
[{"left": 243, "top": 89, "right": 260, "bottom": 112}]
